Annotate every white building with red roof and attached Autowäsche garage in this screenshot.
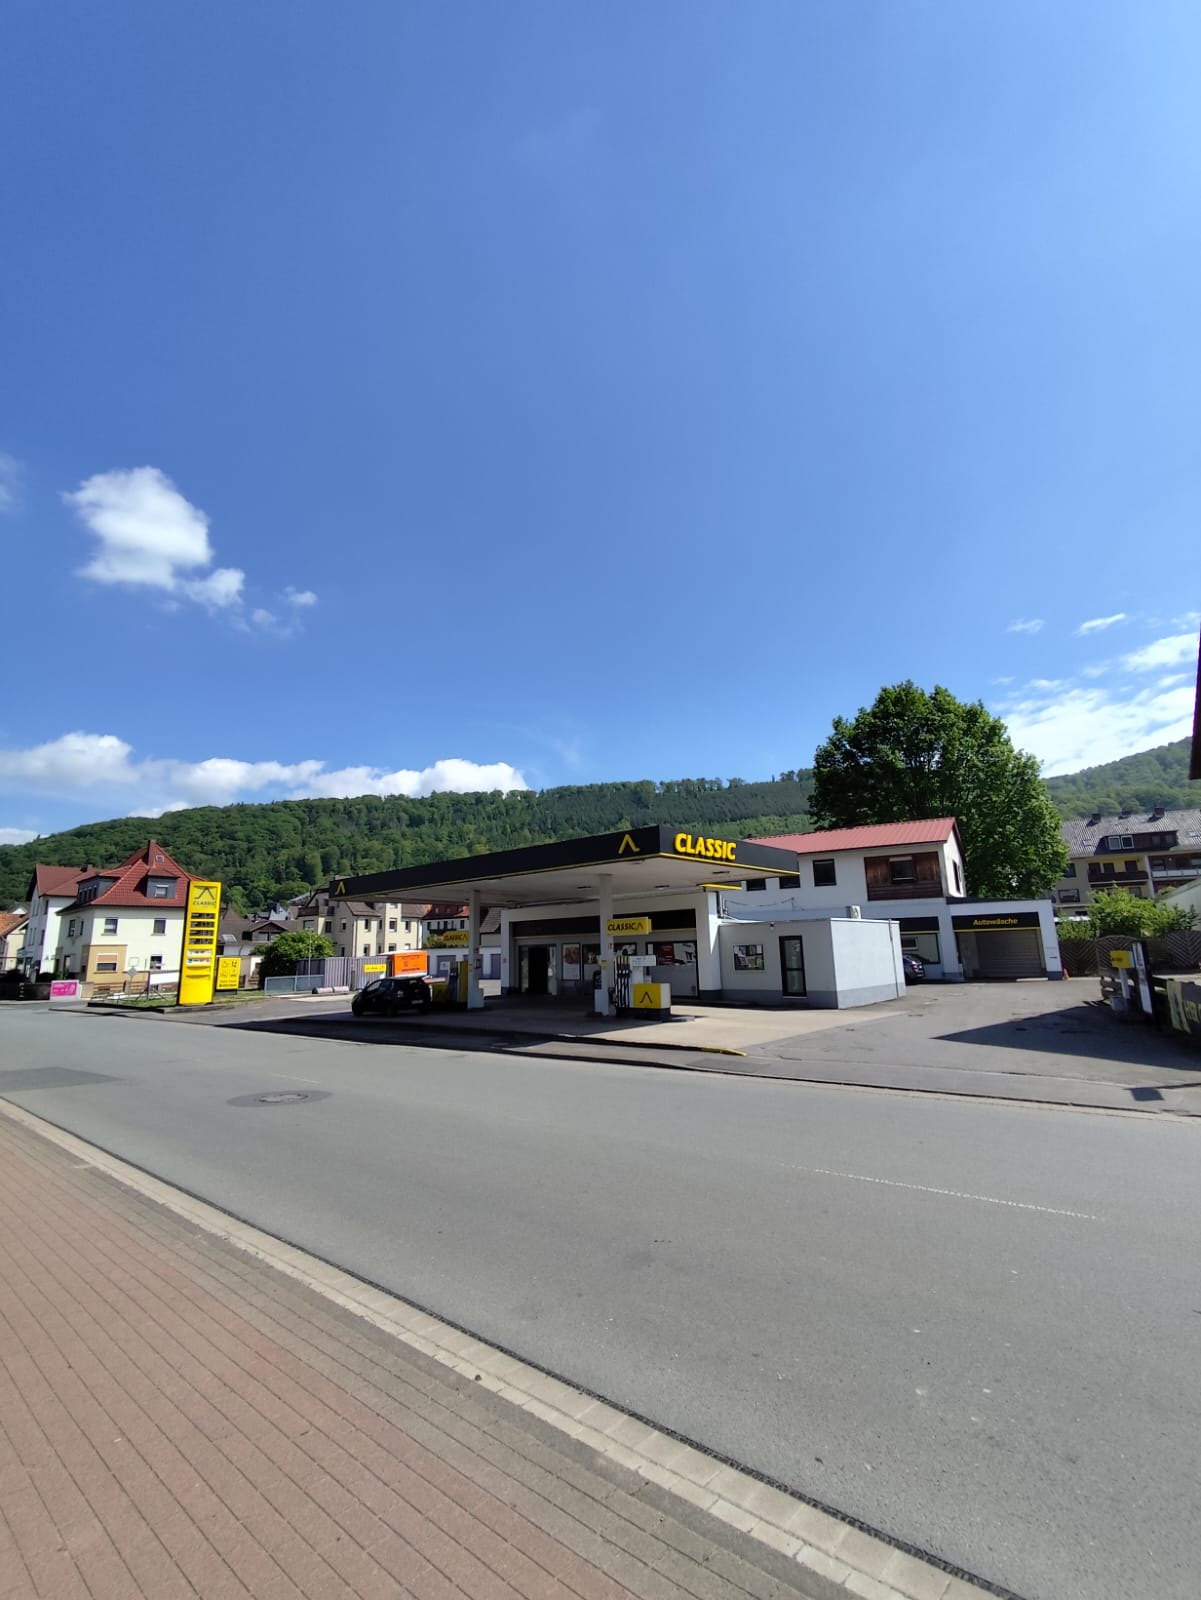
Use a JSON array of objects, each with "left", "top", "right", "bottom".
[{"left": 721, "top": 816, "right": 1062, "bottom": 982}]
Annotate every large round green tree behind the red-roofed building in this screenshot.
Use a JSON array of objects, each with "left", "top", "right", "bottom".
[{"left": 809, "top": 682, "right": 1068, "bottom": 899}]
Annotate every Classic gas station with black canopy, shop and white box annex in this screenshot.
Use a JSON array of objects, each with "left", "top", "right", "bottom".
[{"left": 333, "top": 827, "right": 904, "bottom": 1014}]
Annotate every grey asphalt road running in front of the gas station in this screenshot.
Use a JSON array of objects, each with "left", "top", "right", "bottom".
[{"left": 0, "top": 1006, "right": 1201, "bottom": 1600}]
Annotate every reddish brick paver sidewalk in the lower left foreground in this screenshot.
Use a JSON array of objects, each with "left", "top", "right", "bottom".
[{"left": 0, "top": 1117, "right": 804, "bottom": 1600}]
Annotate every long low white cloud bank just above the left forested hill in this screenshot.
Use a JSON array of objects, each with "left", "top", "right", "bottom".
[{"left": 0, "top": 733, "right": 529, "bottom": 816}]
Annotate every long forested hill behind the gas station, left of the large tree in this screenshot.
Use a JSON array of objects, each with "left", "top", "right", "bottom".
[{"left": 0, "top": 771, "right": 812, "bottom": 910}]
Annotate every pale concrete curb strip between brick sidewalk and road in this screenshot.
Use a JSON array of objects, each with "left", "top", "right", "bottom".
[{"left": 0, "top": 1101, "right": 997, "bottom": 1600}]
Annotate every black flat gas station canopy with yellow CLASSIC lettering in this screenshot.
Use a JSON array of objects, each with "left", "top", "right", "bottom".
[{"left": 333, "top": 827, "right": 796, "bottom": 907}]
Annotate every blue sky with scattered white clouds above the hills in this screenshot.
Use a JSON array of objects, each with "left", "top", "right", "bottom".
[{"left": 0, "top": 0, "right": 1201, "bottom": 842}]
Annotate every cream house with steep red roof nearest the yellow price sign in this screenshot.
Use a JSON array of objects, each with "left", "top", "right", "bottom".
[{"left": 54, "top": 840, "right": 192, "bottom": 984}]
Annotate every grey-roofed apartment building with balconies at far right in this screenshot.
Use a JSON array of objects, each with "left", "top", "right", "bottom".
[{"left": 1052, "top": 806, "right": 1201, "bottom": 915}]
